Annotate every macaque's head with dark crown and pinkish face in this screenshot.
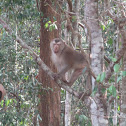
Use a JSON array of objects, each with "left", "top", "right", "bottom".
[{"left": 50, "top": 38, "right": 65, "bottom": 54}]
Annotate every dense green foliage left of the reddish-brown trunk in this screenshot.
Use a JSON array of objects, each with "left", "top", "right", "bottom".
[{"left": 0, "top": 0, "right": 41, "bottom": 126}]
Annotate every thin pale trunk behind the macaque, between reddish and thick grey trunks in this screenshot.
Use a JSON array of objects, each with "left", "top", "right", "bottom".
[{"left": 65, "top": 0, "right": 80, "bottom": 126}]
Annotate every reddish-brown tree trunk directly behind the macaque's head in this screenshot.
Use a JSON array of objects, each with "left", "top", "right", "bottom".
[{"left": 39, "top": 0, "right": 60, "bottom": 126}]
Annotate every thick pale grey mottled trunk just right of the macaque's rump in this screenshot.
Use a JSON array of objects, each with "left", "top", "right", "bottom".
[{"left": 85, "top": 0, "right": 108, "bottom": 126}]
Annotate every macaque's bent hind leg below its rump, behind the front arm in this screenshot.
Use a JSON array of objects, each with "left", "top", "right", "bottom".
[{"left": 69, "top": 69, "right": 83, "bottom": 86}]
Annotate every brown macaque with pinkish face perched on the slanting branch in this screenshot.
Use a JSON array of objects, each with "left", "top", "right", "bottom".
[{"left": 50, "top": 38, "right": 87, "bottom": 86}]
